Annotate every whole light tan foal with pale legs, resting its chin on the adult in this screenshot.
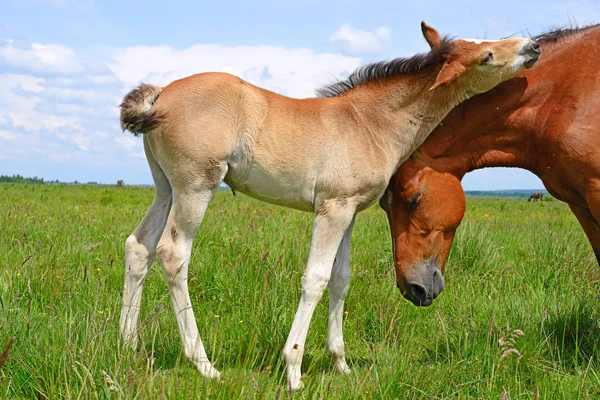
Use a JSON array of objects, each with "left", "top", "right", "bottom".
[{"left": 121, "top": 23, "right": 540, "bottom": 389}]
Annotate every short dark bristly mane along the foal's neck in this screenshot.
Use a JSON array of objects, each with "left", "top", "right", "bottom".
[{"left": 317, "top": 36, "right": 451, "bottom": 97}]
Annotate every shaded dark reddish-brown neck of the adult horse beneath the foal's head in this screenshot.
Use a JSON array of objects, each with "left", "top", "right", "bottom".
[{"left": 413, "top": 77, "right": 537, "bottom": 177}]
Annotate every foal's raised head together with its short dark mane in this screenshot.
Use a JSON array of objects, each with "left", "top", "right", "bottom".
[{"left": 317, "top": 22, "right": 540, "bottom": 102}]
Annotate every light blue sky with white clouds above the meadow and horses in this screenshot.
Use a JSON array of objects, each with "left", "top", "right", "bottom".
[{"left": 0, "top": 0, "right": 600, "bottom": 190}]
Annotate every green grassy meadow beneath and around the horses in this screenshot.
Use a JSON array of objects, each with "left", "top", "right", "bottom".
[{"left": 0, "top": 184, "right": 600, "bottom": 399}]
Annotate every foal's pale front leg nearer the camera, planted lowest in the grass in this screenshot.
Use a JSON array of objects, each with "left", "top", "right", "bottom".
[{"left": 283, "top": 200, "right": 355, "bottom": 390}]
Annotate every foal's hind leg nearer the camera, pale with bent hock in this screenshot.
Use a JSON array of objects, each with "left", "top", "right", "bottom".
[{"left": 157, "top": 166, "right": 226, "bottom": 378}]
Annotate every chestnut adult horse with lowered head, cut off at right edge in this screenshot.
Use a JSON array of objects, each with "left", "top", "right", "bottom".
[{"left": 380, "top": 25, "right": 600, "bottom": 306}]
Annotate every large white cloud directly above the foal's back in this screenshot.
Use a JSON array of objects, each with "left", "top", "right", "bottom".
[{"left": 109, "top": 45, "right": 360, "bottom": 97}]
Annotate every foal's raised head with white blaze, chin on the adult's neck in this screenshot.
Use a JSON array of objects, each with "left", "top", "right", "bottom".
[{"left": 421, "top": 22, "right": 541, "bottom": 96}]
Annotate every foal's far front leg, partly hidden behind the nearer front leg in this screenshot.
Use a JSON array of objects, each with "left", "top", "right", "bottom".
[{"left": 327, "top": 219, "right": 354, "bottom": 374}]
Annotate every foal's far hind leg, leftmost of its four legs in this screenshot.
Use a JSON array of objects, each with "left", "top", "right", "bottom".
[{"left": 120, "top": 139, "right": 171, "bottom": 347}]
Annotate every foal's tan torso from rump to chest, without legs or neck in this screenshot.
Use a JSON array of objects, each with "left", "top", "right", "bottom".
[{"left": 146, "top": 73, "right": 395, "bottom": 211}]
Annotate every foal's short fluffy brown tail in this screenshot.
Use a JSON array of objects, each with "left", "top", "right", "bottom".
[{"left": 120, "top": 83, "right": 165, "bottom": 136}]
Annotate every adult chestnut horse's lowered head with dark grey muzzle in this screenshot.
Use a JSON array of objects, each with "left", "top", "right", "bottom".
[{"left": 380, "top": 156, "right": 466, "bottom": 306}]
